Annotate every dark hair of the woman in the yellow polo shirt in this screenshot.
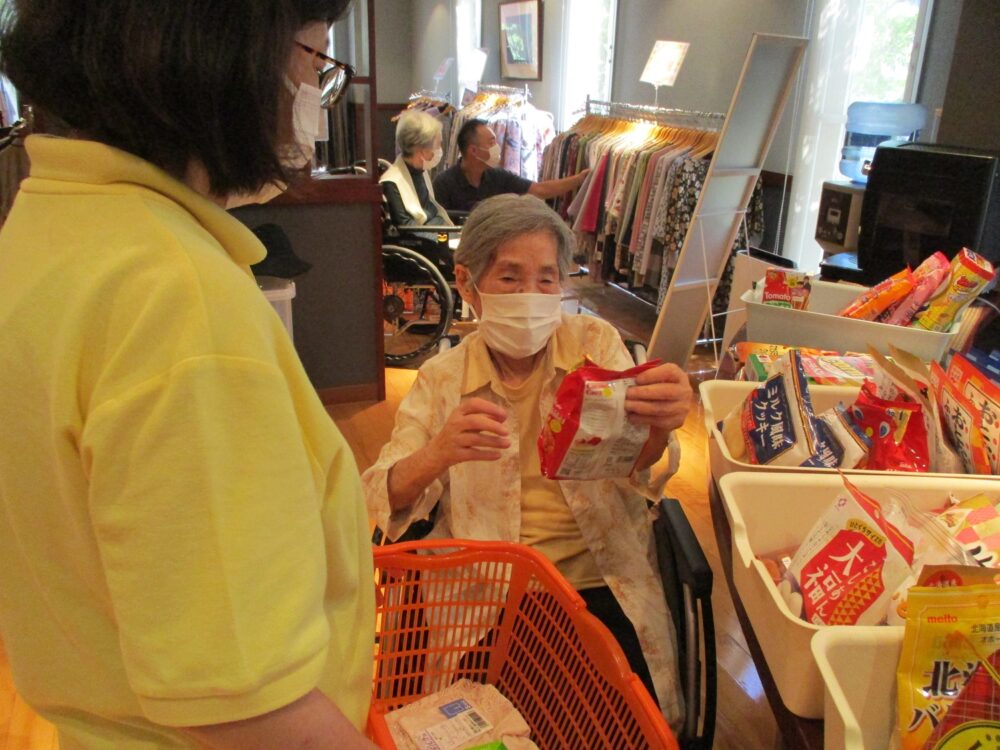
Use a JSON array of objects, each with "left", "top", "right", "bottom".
[{"left": 0, "top": 0, "right": 351, "bottom": 195}]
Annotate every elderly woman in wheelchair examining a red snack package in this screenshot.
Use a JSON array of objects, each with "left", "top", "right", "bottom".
[{"left": 362, "top": 195, "right": 691, "bottom": 726}]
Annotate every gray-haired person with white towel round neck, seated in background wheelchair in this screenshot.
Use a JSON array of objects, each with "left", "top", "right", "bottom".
[{"left": 380, "top": 112, "right": 452, "bottom": 227}]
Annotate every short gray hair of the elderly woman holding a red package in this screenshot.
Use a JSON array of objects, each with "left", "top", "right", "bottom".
[{"left": 455, "top": 195, "right": 576, "bottom": 283}]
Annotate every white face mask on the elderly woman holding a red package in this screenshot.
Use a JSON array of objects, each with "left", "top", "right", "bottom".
[{"left": 477, "top": 289, "right": 562, "bottom": 359}]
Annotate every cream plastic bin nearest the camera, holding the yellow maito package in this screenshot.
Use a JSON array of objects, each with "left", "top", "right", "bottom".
[{"left": 812, "top": 628, "right": 903, "bottom": 750}]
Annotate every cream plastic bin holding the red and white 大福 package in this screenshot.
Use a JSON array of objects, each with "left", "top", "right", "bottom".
[{"left": 719, "top": 472, "right": 1000, "bottom": 719}]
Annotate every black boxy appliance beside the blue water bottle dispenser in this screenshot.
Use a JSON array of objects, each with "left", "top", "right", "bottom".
[{"left": 820, "top": 143, "right": 1000, "bottom": 285}]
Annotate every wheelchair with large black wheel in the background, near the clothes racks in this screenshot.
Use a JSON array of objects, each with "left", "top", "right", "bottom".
[{"left": 379, "top": 159, "right": 468, "bottom": 366}]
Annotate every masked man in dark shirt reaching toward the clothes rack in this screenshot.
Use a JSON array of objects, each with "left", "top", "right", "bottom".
[{"left": 434, "top": 120, "right": 590, "bottom": 211}]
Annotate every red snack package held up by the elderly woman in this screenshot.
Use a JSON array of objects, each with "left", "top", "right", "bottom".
[{"left": 538, "top": 360, "right": 660, "bottom": 479}]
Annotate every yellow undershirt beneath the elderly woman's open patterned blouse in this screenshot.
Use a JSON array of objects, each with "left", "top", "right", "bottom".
[{"left": 503, "top": 366, "right": 607, "bottom": 590}]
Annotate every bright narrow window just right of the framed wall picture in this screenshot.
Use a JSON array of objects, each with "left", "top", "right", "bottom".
[{"left": 556, "top": 0, "right": 618, "bottom": 130}]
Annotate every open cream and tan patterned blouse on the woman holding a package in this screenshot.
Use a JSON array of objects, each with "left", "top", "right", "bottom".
[{"left": 362, "top": 315, "right": 683, "bottom": 727}]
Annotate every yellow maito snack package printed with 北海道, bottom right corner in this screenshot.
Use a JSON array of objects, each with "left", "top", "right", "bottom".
[{"left": 896, "top": 584, "right": 1000, "bottom": 750}]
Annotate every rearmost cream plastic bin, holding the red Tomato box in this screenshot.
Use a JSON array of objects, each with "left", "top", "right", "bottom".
[{"left": 741, "top": 279, "right": 958, "bottom": 361}]
